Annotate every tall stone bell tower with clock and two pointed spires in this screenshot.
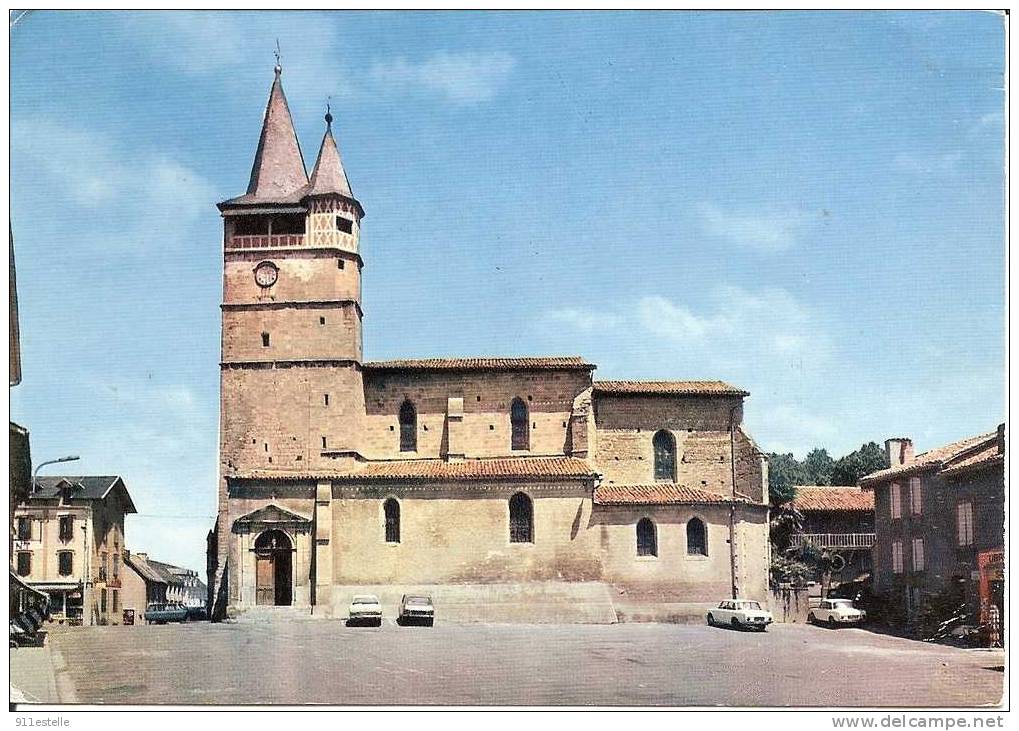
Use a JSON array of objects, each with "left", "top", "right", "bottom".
[{"left": 207, "top": 64, "right": 365, "bottom": 611}]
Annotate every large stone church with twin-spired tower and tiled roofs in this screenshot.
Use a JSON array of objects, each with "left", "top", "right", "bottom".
[{"left": 208, "top": 64, "right": 769, "bottom": 622}]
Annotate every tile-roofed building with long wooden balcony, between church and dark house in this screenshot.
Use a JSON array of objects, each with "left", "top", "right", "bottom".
[{"left": 790, "top": 485, "right": 875, "bottom": 581}]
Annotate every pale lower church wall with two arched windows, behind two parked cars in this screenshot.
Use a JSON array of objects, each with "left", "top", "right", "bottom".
[{"left": 331, "top": 483, "right": 601, "bottom": 584}]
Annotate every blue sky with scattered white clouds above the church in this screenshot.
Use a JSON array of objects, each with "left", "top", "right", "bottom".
[{"left": 11, "top": 12, "right": 1005, "bottom": 569}]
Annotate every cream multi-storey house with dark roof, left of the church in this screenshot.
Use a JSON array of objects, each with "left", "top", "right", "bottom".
[{"left": 12, "top": 476, "right": 137, "bottom": 625}]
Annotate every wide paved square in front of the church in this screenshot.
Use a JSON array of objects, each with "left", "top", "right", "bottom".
[{"left": 31, "top": 620, "right": 1004, "bottom": 707}]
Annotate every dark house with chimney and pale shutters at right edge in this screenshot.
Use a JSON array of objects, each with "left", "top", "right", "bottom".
[{"left": 860, "top": 424, "right": 1005, "bottom": 622}]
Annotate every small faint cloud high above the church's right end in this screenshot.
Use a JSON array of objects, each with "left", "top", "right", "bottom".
[{"left": 698, "top": 203, "right": 817, "bottom": 252}]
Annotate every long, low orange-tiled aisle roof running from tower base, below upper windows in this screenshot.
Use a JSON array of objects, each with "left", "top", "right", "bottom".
[{"left": 233, "top": 457, "right": 597, "bottom": 482}]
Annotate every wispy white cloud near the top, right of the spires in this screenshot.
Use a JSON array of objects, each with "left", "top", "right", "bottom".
[{"left": 368, "top": 51, "right": 517, "bottom": 104}]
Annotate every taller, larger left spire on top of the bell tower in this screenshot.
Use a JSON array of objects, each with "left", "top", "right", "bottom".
[{"left": 248, "top": 60, "right": 308, "bottom": 201}]
